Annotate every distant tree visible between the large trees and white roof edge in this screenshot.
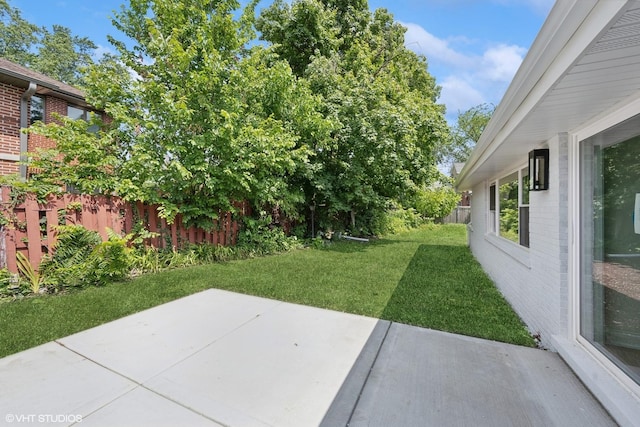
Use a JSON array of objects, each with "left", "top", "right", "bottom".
[{"left": 437, "top": 104, "right": 495, "bottom": 163}]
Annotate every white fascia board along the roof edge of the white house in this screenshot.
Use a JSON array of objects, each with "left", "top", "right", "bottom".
[{"left": 457, "top": 0, "right": 630, "bottom": 190}]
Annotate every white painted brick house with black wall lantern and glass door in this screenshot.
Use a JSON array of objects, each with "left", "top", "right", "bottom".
[{"left": 457, "top": 0, "right": 640, "bottom": 425}]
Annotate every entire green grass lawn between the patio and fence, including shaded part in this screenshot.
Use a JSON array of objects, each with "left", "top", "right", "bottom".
[{"left": 0, "top": 225, "right": 534, "bottom": 357}]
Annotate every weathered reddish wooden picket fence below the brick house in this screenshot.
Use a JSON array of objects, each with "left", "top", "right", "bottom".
[{"left": 0, "top": 186, "right": 248, "bottom": 273}]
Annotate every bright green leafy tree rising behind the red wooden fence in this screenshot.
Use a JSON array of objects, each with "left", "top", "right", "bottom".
[{"left": 28, "top": 0, "right": 328, "bottom": 227}]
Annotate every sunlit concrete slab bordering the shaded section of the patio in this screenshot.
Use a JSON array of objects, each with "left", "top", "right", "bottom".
[{"left": 145, "top": 304, "right": 377, "bottom": 427}]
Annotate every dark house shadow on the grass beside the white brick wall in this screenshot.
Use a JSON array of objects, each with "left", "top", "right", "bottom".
[{"left": 380, "top": 244, "right": 534, "bottom": 346}]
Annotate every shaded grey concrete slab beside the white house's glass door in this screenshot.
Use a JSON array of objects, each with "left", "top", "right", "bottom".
[{"left": 338, "top": 323, "right": 616, "bottom": 427}]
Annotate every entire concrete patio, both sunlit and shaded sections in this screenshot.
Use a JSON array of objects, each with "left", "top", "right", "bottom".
[{"left": 0, "top": 290, "right": 615, "bottom": 427}]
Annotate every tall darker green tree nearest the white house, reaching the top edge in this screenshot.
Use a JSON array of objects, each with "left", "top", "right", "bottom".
[{"left": 257, "top": 0, "right": 449, "bottom": 232}]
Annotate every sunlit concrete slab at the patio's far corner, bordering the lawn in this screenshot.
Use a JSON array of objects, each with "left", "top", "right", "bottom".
[{"left": 58, "top": 291, "right": 282, "bottom": 383}]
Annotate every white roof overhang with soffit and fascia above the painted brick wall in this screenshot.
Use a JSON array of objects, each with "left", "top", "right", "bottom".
[{"left": 456, "top": 0, "right": 640, "bottom": 190}]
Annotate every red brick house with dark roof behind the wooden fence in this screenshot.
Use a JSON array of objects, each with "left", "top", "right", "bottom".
[{"left": 0, "top": 58, "right": 100, "bottom": 178}]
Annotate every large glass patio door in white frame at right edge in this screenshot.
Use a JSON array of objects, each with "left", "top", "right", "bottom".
[{"left": 579, "top": 116, "right": 640, "bottom": 384}]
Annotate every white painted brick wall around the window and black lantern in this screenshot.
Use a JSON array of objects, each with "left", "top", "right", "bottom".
[{"left": 469, "top": 134, "right": 568, "bottom": 349}]
